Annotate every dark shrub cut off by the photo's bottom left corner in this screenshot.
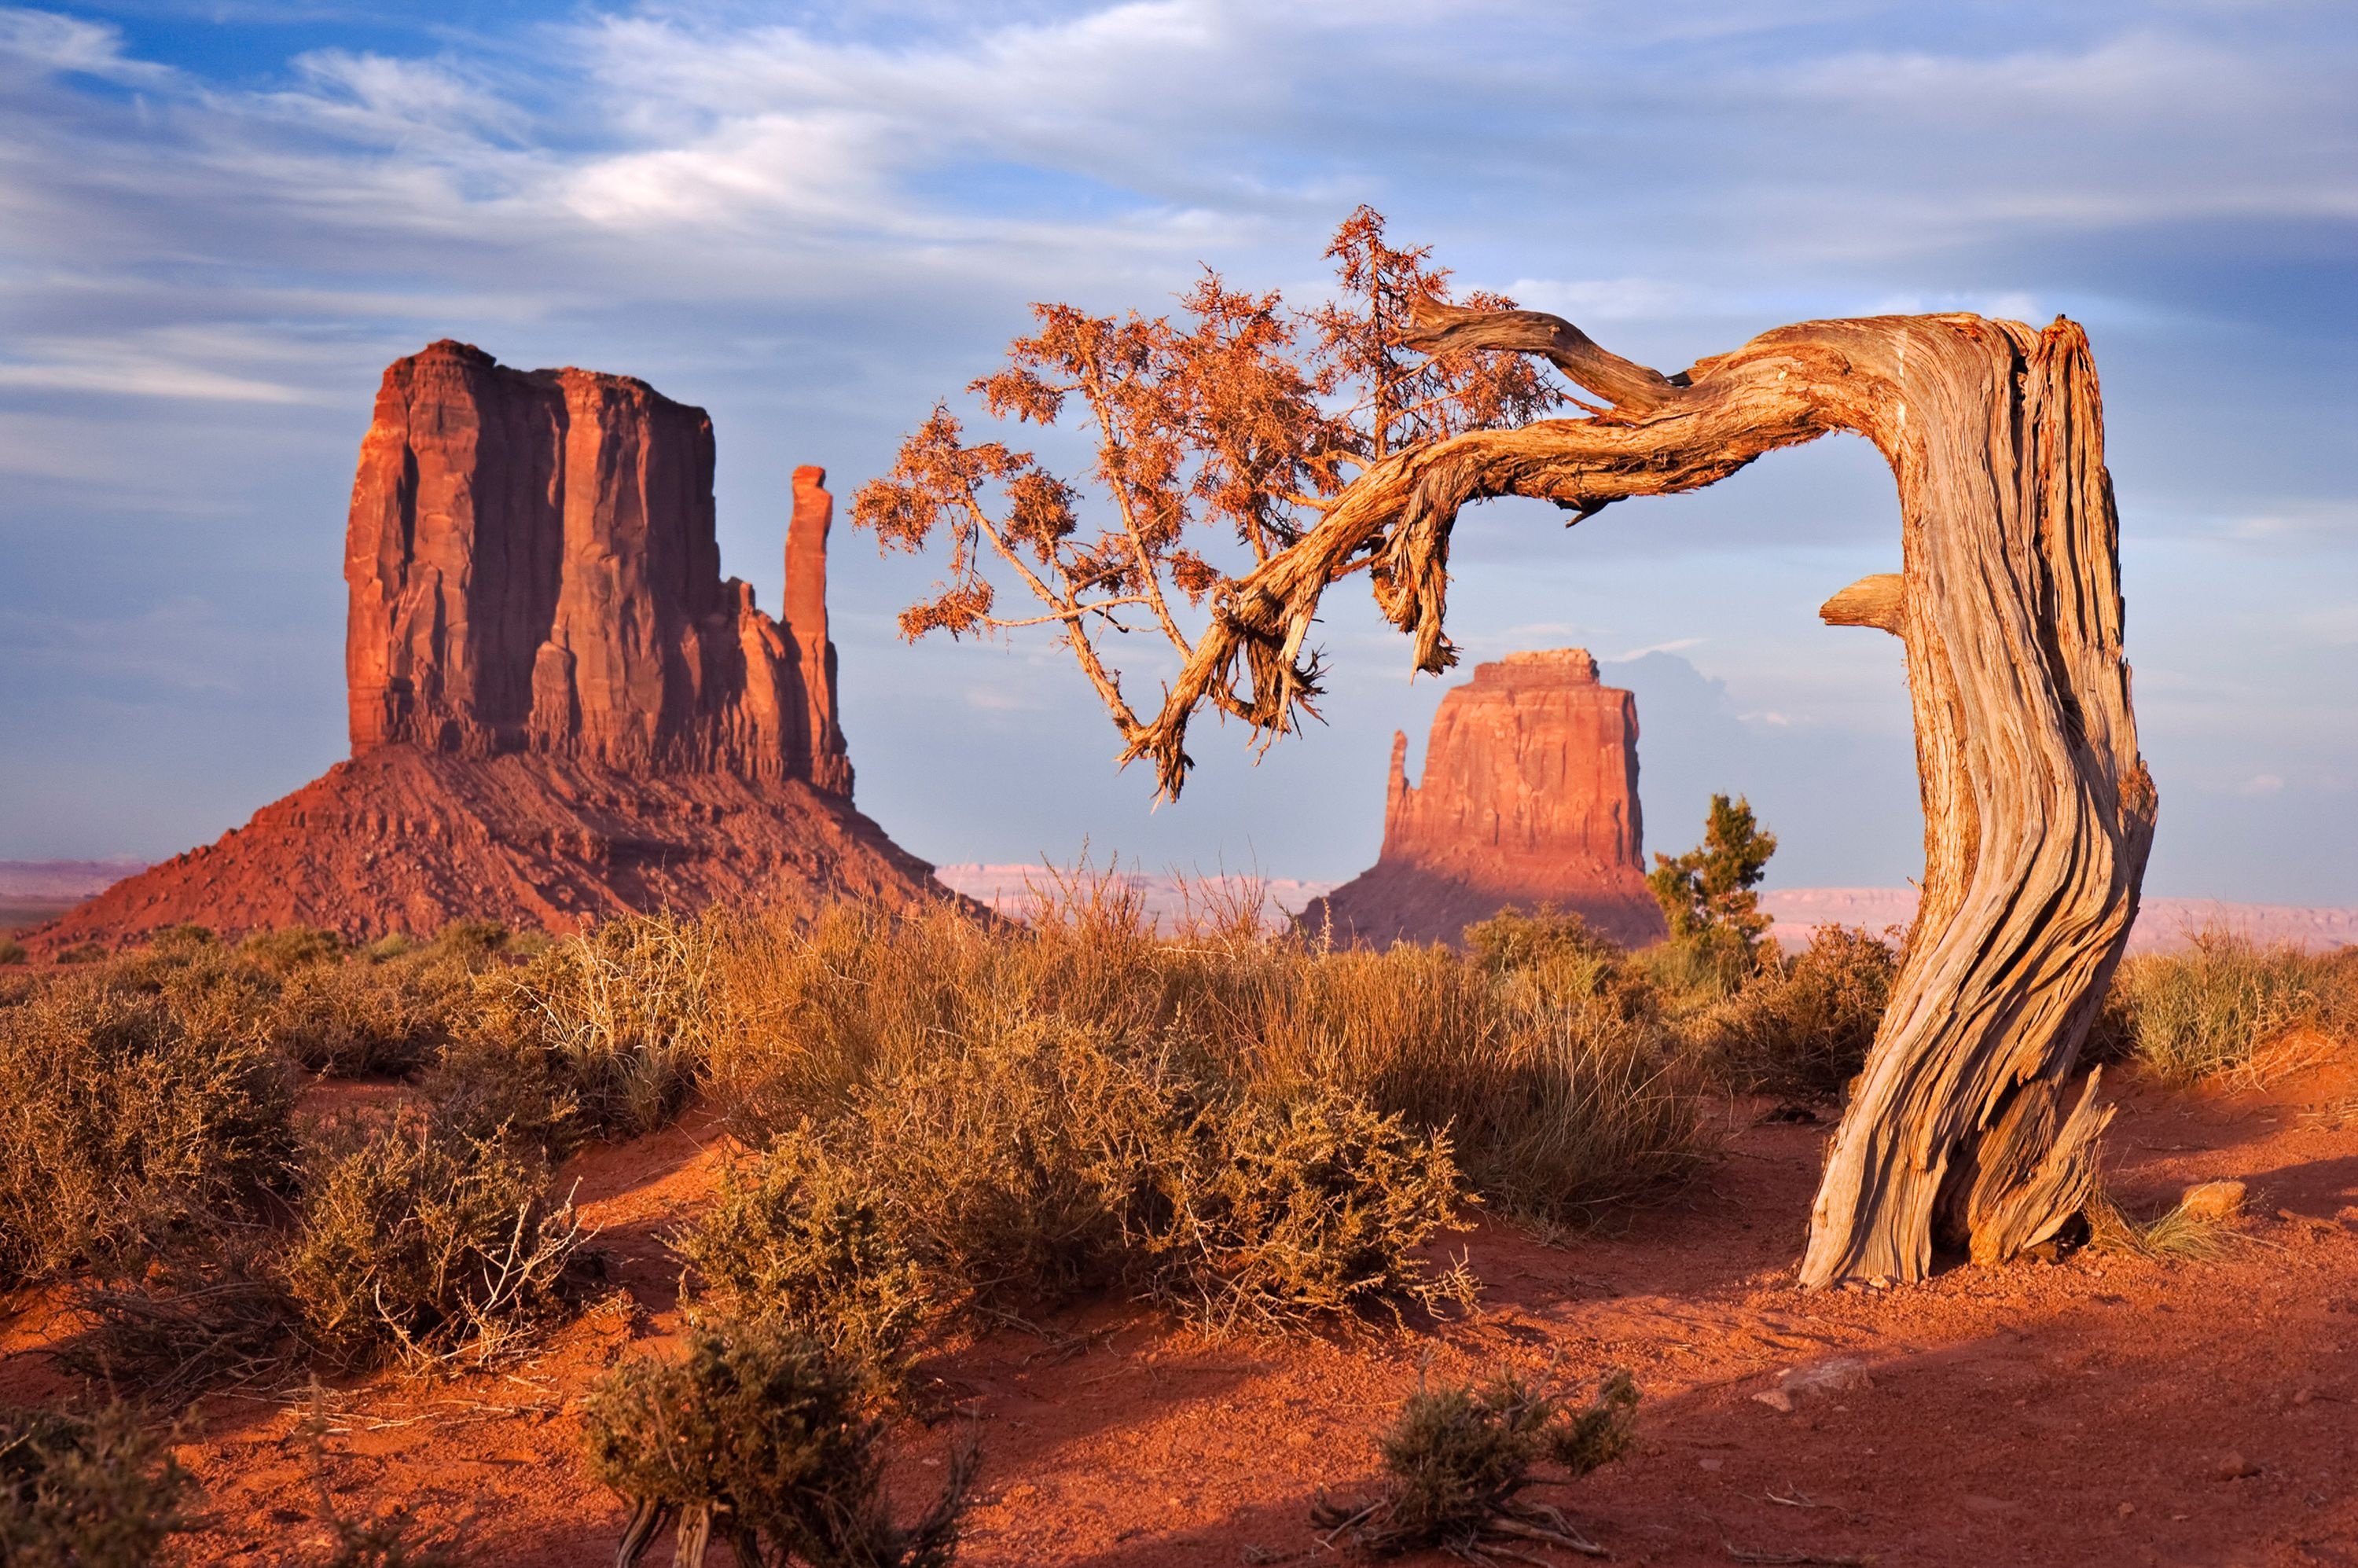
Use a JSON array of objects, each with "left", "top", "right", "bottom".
[{"left": 0, "top": 1405, "right": 189, "bottom": 1568}]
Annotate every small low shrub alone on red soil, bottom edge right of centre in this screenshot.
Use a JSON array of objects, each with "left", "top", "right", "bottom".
[{"left": 1311, "top": 1372, "right": 1639, "bottom": 1563}]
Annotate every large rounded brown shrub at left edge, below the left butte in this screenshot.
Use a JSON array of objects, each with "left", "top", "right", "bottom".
[{"left": 0, "top": 971, "right": 295, "bottom": 1280}]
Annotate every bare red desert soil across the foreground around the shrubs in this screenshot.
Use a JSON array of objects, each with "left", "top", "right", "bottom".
[{"left": 0, "top": 1070, "right": 2358, "bottom": 1568}]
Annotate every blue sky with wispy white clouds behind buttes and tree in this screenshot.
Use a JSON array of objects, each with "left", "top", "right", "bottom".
[{"left": 0, "top": 0, "right": 2358, "bottom": 903}]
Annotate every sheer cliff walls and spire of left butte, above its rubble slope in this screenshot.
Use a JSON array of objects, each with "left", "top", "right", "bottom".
[{"left": 344, "top": 340, "right": 851, "bottom": 797}]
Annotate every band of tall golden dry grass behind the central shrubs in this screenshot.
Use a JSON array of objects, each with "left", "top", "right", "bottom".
[{"left": 710, "top": 884, "right": 1700, "bottom": 1219}]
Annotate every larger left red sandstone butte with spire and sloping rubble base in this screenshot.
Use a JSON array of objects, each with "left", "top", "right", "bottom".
[{"left": 31, "top": 342, "right": 953, "bottom": 950}]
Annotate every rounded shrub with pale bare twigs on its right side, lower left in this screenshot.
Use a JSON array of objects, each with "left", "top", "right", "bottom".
[{"left": 285, "top": 1113, "right": 582, "bottom": 1365}]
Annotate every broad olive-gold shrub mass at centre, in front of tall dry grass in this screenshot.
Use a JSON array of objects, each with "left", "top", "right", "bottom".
[{"left": 679, "top": 1026, "right": 1467, "bottom": 1363}]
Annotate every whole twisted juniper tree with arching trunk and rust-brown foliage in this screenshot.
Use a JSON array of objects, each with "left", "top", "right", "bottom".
[{"left": 856, "top": 207, "right": 2158, "bottom": 1285}]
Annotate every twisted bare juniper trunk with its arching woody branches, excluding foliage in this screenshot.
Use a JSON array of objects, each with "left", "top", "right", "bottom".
[{"left": 1129, "top": 307, "right": 2155, "bottom": 1287}]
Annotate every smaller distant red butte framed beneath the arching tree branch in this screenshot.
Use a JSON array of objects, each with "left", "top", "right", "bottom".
[{"left": 1302, "top": 648, "right": 1665, "bottom": 946}]
